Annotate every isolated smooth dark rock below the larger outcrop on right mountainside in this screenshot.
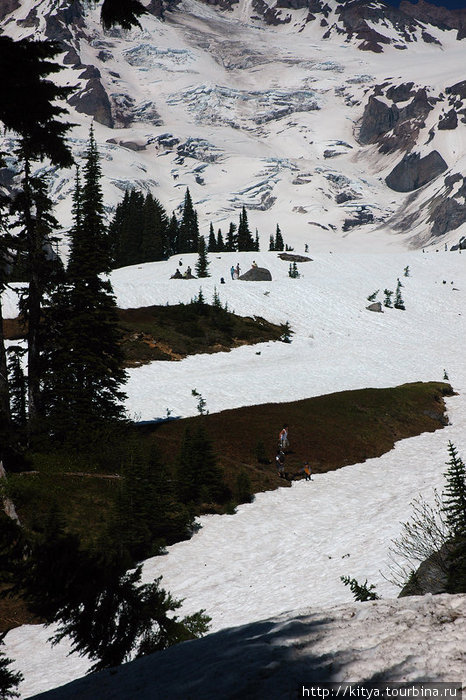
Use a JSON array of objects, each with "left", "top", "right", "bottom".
[{"left": 385, "top": 151, "right": 448, "bottom": 192}]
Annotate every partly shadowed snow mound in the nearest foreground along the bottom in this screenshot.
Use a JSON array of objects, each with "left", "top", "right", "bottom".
[{"left": 21, "top": 592, "right": 466, "bottom": 700}]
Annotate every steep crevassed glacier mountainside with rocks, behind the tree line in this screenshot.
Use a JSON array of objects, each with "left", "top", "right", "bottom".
[{"left": 0, "top": 0, "right": 466, "bottom": 249}]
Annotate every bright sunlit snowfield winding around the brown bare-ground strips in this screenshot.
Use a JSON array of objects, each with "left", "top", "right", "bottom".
[{"left": 6, "top": 247, "right": 466, "bottom": 697}]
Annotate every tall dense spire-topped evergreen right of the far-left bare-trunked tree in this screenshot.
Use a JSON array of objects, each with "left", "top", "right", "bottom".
[{"left": 43, "top": 130, "right": 126, "bottom": 444}]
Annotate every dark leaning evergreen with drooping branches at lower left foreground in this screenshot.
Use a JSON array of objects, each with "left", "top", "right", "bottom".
[{"left": 18, "top": 519, "right": 208, "bottom": 671}]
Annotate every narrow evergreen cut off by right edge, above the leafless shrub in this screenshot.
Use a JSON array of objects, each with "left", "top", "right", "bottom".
[{"left": 442, "top": 441, "right": 466, "bottom": 536}]
